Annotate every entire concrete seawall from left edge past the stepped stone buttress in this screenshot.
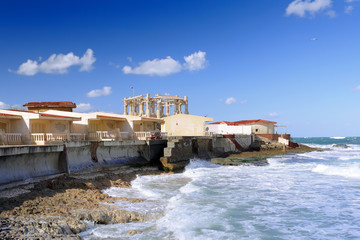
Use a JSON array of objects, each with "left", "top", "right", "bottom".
[{"left": 0, "top": 135, "right": 253, "bottom": 185}]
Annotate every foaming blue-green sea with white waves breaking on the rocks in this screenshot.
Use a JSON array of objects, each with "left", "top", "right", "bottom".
[{"left": 81, "top": 137, "right": 360, "bottom": 240}]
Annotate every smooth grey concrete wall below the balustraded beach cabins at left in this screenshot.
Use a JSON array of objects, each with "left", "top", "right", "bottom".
[{"left": 0, "top": 140, "right": 167, "bottom": 185}]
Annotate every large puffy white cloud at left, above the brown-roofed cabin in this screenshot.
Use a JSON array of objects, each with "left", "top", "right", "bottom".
[{"left": 16, "top": 49, "right": 96, "bottom": 76}]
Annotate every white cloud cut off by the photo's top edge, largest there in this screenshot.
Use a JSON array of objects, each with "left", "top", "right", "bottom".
[{"left": 286, "top": 0, "right": 332, "bottom": 17}]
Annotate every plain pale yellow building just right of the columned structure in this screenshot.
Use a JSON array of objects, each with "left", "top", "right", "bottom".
[{"left": 161, "top": 114, "right": 213, "bottom": 136}]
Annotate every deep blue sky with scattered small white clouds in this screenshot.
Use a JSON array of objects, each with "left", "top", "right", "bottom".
[{"left": 0, "top": 0, "right": 360, "bottom": 137}]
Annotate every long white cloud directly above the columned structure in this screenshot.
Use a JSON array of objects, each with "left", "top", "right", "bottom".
[{"left": 122, "top": 51, "right": 207, "bottom": 76}]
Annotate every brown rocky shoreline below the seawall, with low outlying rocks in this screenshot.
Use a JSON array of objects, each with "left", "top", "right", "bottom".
[{"left": 0, "top": 145, "right": 318, "bottom": 239}]
